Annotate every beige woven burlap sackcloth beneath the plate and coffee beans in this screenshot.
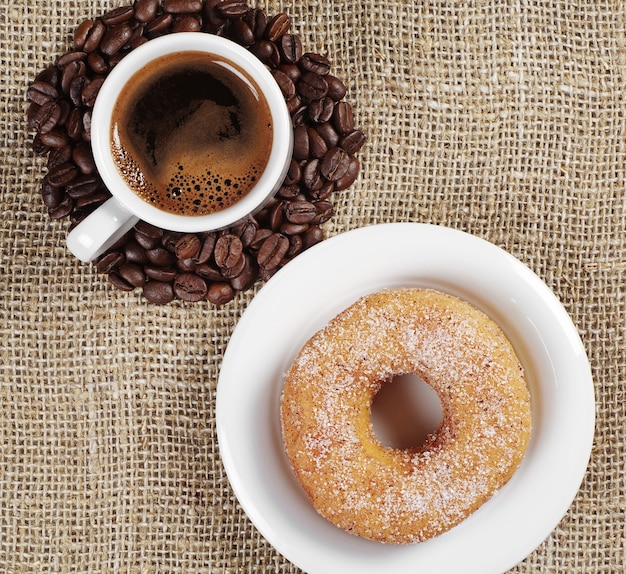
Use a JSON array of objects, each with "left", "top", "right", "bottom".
[{"left": 0, "top": 0, "right": 626, "bottom": 574}]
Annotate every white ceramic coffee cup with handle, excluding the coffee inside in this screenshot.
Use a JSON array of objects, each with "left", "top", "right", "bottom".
[{"left": 67, "top": 32, "right": 293, "bottom": 261}]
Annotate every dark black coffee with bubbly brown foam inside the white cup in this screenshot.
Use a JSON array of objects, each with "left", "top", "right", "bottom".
[{"left": 111, "top": 52, "right": 273, "bottom": 215}]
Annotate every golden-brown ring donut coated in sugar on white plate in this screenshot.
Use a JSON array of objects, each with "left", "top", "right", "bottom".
[{"left": 280, "top": 288, "right": 531, "bottom": 543}]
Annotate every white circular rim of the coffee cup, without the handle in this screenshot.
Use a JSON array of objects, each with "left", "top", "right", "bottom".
[{"left": 91, "top": 32, "right": 293, "bottom": 232}]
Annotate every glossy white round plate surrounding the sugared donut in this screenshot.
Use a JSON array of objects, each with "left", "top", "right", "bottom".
[{"left": 216, "top": 223, "right": 595, "bottom": 574}]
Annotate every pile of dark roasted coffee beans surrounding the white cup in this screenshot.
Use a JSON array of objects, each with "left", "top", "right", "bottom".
[{"left": 27, "top": 0, "right": 365, "bottom": 305}]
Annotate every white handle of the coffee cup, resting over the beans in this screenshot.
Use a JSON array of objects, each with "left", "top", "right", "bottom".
[{"left": 67, "top": 197, "right": 139, "bottom": 263}]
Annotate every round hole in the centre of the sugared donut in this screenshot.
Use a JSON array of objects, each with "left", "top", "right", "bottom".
[{"left": 371, "top": 373, "right": 443, "bottom": 449}]
